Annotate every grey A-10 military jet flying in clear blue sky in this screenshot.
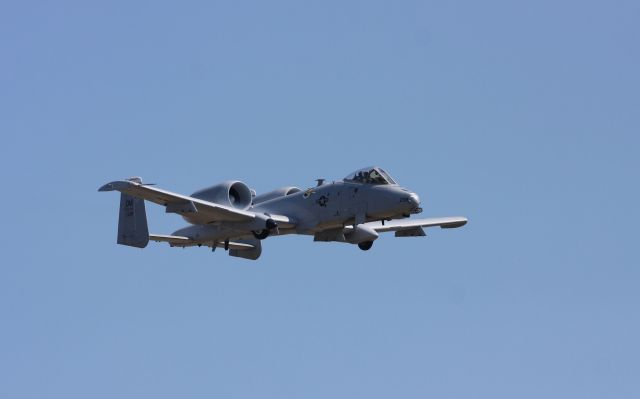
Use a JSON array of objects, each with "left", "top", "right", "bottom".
[{"left": 98, "top": 167, "right": 467, "bottom": 259}]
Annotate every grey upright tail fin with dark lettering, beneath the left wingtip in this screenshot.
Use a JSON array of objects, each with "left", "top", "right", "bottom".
[{"left": 118, "top": 194, "right": 149, "bottom": 248}]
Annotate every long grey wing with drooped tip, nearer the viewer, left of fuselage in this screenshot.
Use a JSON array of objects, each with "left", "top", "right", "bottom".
[{"left": 98, "top": 180, "right": 255, "bottom": 223}]
